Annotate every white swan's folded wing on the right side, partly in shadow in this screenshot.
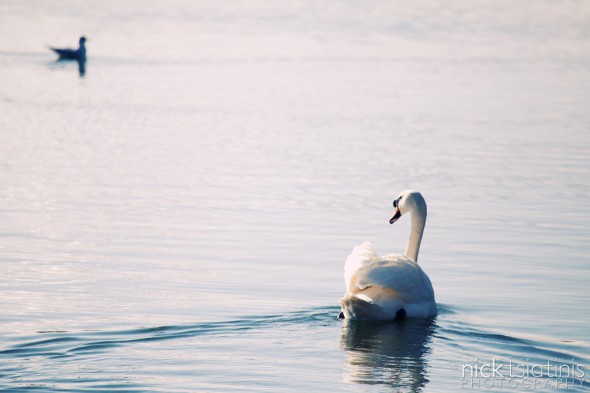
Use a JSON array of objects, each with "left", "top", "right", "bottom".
[{"left": 356, "top": 256, "right": 434, "bottom": 303}]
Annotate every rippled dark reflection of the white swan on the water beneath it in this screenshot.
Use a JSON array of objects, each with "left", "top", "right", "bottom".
[{"left": 340, "top": 319, "right": 436, "bottom": 392}]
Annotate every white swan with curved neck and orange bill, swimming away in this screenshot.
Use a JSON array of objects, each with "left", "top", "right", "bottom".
[{"left": 339, "top": 190, "right": 436, "bottom": 320}]
